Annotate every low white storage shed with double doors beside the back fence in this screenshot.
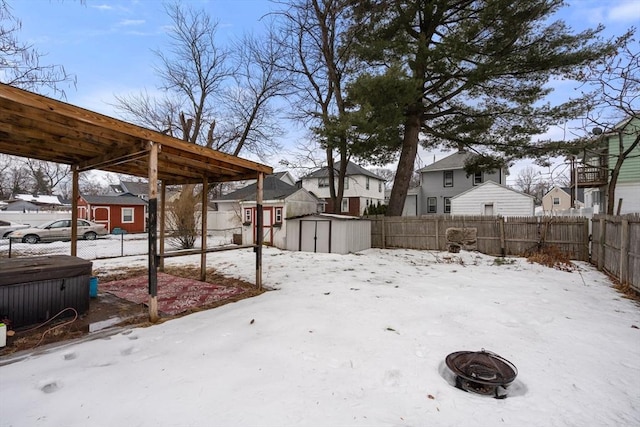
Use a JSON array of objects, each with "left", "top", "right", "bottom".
[{"left": 287, "top": 214, "right": 371, "bottom": 254}]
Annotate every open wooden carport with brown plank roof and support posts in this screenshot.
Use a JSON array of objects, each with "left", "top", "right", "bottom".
[{"left": 0, "top": 84, "right": 273, "bottom": 321}]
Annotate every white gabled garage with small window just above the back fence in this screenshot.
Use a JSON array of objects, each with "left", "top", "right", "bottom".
[{"left": 451, "top": 181, "right": 535, "bottom": 216}]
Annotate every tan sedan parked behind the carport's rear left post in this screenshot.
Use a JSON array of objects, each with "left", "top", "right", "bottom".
[{"left": 9, "top": 219, "right": 108, "bottom": 243}]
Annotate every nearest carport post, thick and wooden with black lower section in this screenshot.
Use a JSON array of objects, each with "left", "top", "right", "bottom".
[{"left": 147, "top": 141, "right": 159, "bottom": 323}]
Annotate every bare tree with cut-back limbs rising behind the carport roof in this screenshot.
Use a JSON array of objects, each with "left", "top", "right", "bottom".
[{"left": 116, "top": 3, "right": 287, "bottom": 248}]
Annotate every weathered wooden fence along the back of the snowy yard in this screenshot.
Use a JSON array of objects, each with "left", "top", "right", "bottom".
[{"left": 369, "top": 215, "right": 589, "bottom": 261}]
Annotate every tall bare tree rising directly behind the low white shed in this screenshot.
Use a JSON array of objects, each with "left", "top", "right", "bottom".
[{"left": 278, "top": 0, "right": 352, "bottom": 214}]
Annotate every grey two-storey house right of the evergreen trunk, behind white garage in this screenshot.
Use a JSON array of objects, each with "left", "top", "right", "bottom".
[{"left": 416, "top": 150, "right": 510, "bottom": 216}]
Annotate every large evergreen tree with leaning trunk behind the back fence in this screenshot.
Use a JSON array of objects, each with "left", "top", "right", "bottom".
[{"left": 347, "top": 0, "right": 625, "bottom": 215}]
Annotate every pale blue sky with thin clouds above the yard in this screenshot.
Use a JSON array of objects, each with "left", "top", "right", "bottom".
[{"left": 9, "top": 0, "right": 640, "bottom": 183}]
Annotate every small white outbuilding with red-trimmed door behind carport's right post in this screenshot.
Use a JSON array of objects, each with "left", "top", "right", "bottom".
[{"left": 214, "top": 174, "right": 323, "bottom": 249}]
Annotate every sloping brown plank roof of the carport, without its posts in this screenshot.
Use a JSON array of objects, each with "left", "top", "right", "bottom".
[{"left": 0, "top": 84, "right": 273, "bottom": 185}]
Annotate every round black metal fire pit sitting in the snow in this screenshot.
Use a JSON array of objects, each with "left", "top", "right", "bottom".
[{"left": 445, "top": 349, "right": 518, "bottom": 399}]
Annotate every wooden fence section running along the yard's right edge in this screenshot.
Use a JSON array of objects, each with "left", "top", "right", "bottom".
[{"left": 591, "top": 214, "right": 640, "bottom": 293}]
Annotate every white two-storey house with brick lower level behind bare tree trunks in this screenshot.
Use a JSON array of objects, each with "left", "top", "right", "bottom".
[{"left": 300, "top": 162, "right": 385, "bottom": 216}]
